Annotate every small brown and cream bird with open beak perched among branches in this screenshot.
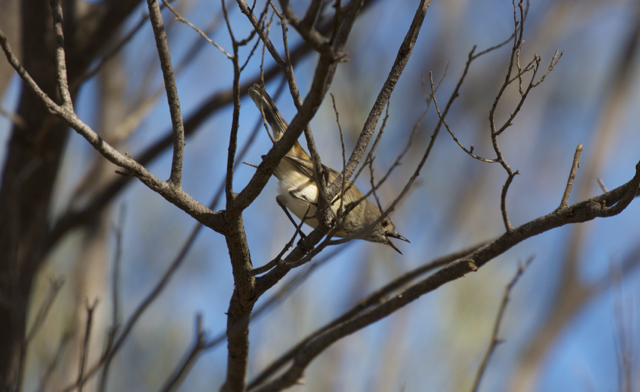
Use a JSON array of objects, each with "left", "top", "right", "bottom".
[{"left": 249, "top": 83, "right": 409, "bottom": 254}]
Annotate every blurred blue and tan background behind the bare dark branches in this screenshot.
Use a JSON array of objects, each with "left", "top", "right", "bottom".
[{"left": 0, "top": 0, "right": 640, "bottom": 391}]
